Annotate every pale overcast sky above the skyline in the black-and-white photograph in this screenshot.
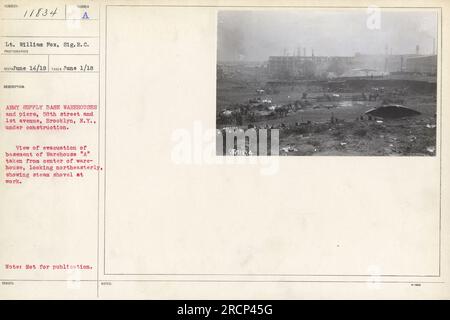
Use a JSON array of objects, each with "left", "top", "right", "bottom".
[{"left": 217, "top": 8, "right": 438, "bottom": 61}]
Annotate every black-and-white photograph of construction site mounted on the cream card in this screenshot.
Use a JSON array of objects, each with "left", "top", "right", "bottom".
[{"left": 216, "top": 6, "right": 439, "bottom": 156}]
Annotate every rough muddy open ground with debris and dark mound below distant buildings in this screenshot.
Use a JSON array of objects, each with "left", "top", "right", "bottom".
[{"left": 216, "top": 69, "right": 437, "bottom": 156}]
